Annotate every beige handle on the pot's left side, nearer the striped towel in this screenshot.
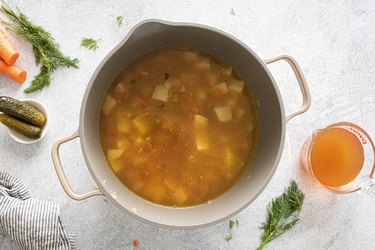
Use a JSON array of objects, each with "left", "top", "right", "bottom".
[{"left": 51, "top": 130, "right": 103, "bottom": 201}]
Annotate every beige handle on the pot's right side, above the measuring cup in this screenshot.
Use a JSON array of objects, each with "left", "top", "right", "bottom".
[{"left": 263, "top": 55, "right": 311, "bottom": 122}]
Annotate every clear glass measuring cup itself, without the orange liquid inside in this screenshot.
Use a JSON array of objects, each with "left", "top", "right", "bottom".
[{"left": 300, "top": 122, "right": 375, "bottom": 194}]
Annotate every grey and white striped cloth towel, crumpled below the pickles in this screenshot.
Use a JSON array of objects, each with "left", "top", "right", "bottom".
[{"left": 0, "top": 171, "right": 75, "bottom": 250}]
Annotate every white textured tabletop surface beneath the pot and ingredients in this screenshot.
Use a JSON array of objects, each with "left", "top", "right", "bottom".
[{"left": 0, "top": 0, "right": 375, "bottom": 249}]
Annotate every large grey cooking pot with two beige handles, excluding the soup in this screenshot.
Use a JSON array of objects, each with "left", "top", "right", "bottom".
[{"left": 52, "top": 20, "right": 311, "bottom": 229}]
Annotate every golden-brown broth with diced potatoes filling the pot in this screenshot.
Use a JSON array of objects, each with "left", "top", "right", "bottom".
[{"left": 100, "top": 48, "right": 258, "bottom": 207}]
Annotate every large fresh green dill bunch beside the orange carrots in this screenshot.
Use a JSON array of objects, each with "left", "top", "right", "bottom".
[{"left": 0, "top": 1, "right": 79, "bottom": 93}]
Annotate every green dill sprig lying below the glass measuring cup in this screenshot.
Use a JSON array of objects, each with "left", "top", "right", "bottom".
[{"left": 257, "top": 180, "right": 304, "bottom": 250}]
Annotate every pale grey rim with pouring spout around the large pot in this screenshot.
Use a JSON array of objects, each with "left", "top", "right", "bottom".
[{"left": 78, "top": 19, "right": 286, "bottom": 230}]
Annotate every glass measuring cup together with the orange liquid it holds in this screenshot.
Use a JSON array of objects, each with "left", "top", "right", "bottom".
[{"left": 301, "top": 122, "right": 375, "bottom": 194}]
